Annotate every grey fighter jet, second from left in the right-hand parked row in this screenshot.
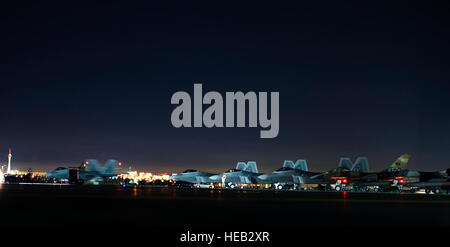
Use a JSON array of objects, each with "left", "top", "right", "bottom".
[{"left": 209, "top": 161, "right": 260, "bottom": 188}]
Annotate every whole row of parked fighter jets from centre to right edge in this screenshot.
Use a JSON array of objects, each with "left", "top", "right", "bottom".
[{"left": 171, "top": 154, "right": 450, "bottom": 194}]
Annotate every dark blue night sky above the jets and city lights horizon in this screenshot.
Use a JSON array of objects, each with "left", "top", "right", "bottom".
[{"left": 0, "top": 1, "right": 450, "bottom": 172}]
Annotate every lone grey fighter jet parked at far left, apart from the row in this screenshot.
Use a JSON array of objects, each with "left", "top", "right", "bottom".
[{"left": 45, "top": 159, "right": 121, "bottom": 183}]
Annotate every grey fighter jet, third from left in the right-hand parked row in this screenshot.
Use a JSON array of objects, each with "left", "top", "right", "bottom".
[{"left": 258, "top": 160, "right": 319, "bottom": 189}]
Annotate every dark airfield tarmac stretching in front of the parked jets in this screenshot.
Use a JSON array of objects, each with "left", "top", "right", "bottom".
[{"left": 0, "top": 184, "right": 450, "bottom": 229}]
